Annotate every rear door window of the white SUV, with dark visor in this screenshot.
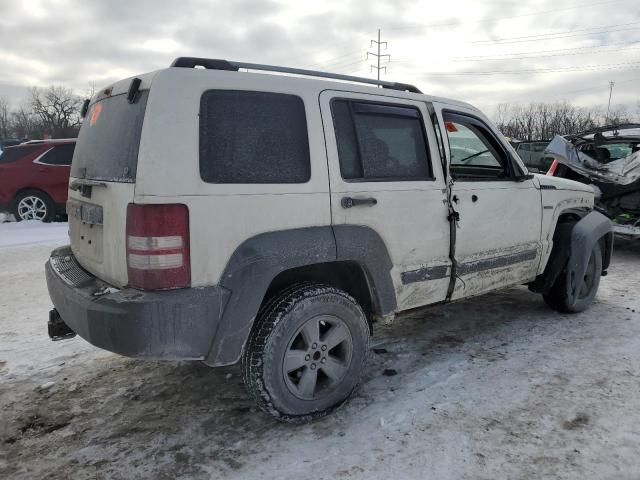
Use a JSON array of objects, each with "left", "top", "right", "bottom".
[{"left": 331, "top": 99, "right": 432, "bottom": 181}]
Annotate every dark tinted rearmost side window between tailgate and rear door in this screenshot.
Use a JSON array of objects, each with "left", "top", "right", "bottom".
[{"left": 200, "top": 90, "right": 311, "bottom": 183}]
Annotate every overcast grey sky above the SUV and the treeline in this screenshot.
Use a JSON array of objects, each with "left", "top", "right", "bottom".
[{"left": 0, "top": 0, "right": 640, "bottom": 115}]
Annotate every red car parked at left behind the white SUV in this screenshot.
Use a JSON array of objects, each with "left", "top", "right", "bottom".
[{"left": 0, "top": 139, "right": 76, "bottom": 222}]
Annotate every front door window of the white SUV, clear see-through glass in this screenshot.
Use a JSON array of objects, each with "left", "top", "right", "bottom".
[{"left": 443, "top": 112, "right": 509, "bottom": 178}]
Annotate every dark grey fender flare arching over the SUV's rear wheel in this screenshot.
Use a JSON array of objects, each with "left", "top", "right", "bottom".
[{"left": 204, "top": 225, "right": 396, "bottom": 366}]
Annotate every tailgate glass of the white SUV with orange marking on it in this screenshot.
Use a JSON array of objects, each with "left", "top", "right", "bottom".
[{"left": 71, "top": 90, "right": 149, "bottom": 182}]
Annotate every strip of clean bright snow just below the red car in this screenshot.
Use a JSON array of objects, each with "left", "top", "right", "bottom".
[{"left": 0, "top": 220, "right": 69, "bottom": 248}]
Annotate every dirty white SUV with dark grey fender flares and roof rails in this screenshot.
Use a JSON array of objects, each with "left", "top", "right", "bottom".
[{"left": 46, "top": 58, "right": 612, "bottom": 421}]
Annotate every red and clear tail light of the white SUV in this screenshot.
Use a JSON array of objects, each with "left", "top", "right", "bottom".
[{"left": 127, "top": 203, "right": 191, "bottom": 290}]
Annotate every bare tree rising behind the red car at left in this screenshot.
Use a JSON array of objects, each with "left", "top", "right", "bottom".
[{"left": 29, "top": 86, "right": 82, "bottom": 138}]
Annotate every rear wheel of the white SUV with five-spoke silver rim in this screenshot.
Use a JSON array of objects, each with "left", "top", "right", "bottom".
[{"left": 242, "top": 283, "right": 369, "bottom": 422}]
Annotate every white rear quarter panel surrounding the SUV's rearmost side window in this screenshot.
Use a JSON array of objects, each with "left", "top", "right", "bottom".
[{"left": 135, "top": 68, "right": 331, "bottom": 287}]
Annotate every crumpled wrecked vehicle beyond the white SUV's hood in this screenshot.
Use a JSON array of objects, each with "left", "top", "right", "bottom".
[{"left": 545, "top": 123, "right": 640, "bottom": 238}]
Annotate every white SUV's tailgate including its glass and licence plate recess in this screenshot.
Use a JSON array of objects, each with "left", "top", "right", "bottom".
[{"left": 67, "top": 75, "right": 150, "bottom": 287}]
